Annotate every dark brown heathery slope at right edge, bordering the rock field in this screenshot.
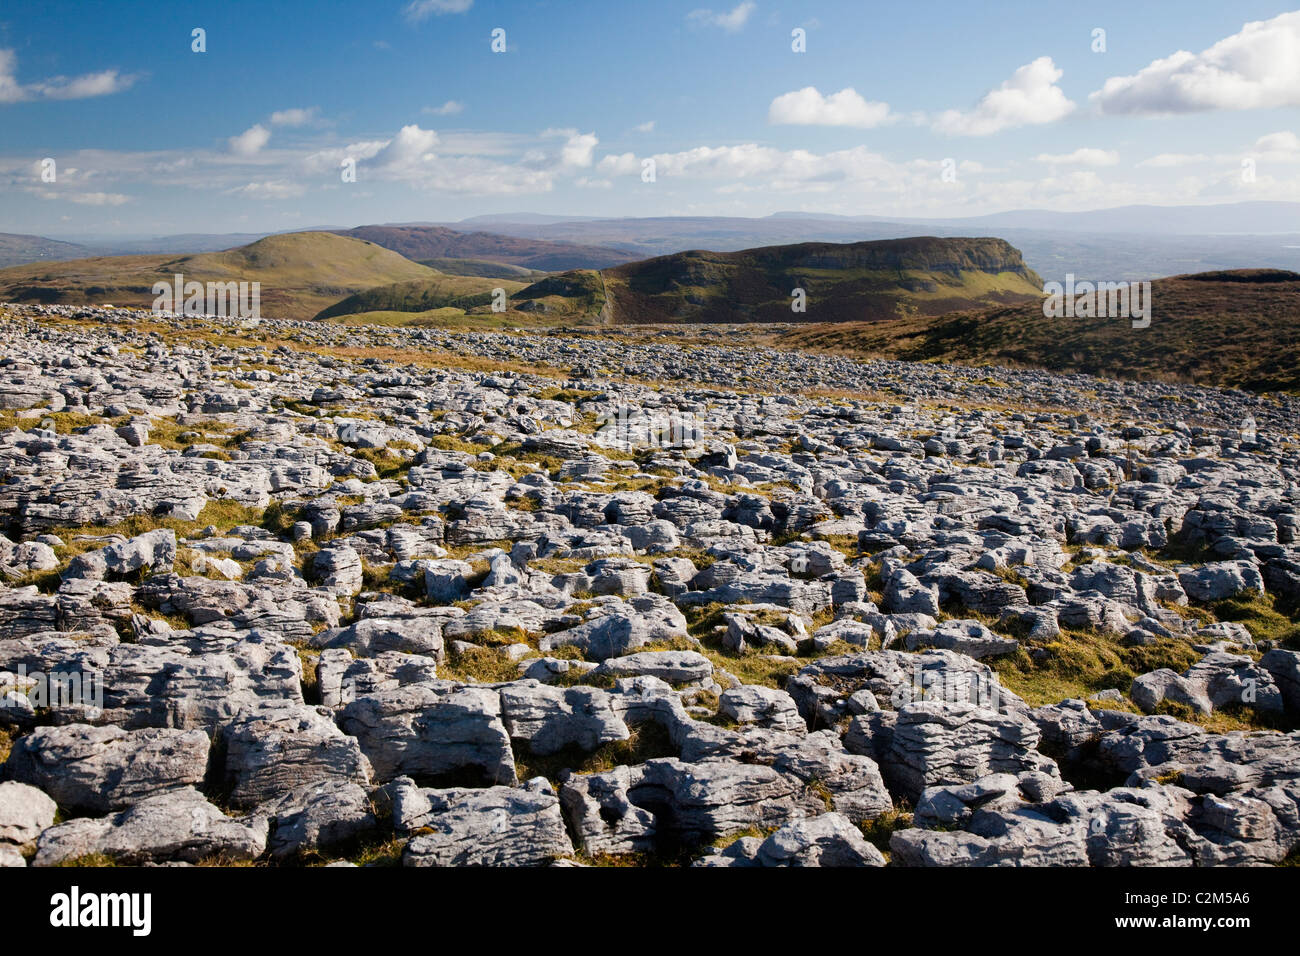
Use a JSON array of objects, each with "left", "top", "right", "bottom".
[{"left": 774, "top": 269, "right": 1300, "bottom": 392}]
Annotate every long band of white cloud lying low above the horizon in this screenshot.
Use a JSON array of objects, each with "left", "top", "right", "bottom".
[{"left": 15, "top": 104, "right": 1300, "bottom": 218}]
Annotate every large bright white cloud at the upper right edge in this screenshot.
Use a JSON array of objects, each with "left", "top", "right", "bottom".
[{"left": 1089, "top": 10, "right": 1300, "bottom": 113}]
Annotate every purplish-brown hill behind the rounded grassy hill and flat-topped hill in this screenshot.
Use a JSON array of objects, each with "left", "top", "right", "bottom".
[{"left": 325, "top": 225, "right": 636, "bottom": 272}]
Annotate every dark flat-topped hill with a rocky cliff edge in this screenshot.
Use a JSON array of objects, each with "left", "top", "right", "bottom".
[{"left": 514, "top": 237, "right": 1041, "bottom": 324}]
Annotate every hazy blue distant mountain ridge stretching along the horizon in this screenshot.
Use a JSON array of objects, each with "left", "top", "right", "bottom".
[{"left": 12, "top": 202, "right": 1300, "bottom": 281}]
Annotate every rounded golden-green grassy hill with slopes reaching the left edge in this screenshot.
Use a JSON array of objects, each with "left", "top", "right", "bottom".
[{"left": 0, "top": 233, "right": 438, "bottom": 319}]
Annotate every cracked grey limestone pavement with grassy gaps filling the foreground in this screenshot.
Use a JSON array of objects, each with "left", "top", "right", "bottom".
[{"left": 0, "top": 306, "right": 1300, "bottom": 866}]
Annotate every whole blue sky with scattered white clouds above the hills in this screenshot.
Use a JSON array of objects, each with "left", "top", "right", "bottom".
[{"left": 0, "top": 0, "right": 1300, "bottom": 237}]
